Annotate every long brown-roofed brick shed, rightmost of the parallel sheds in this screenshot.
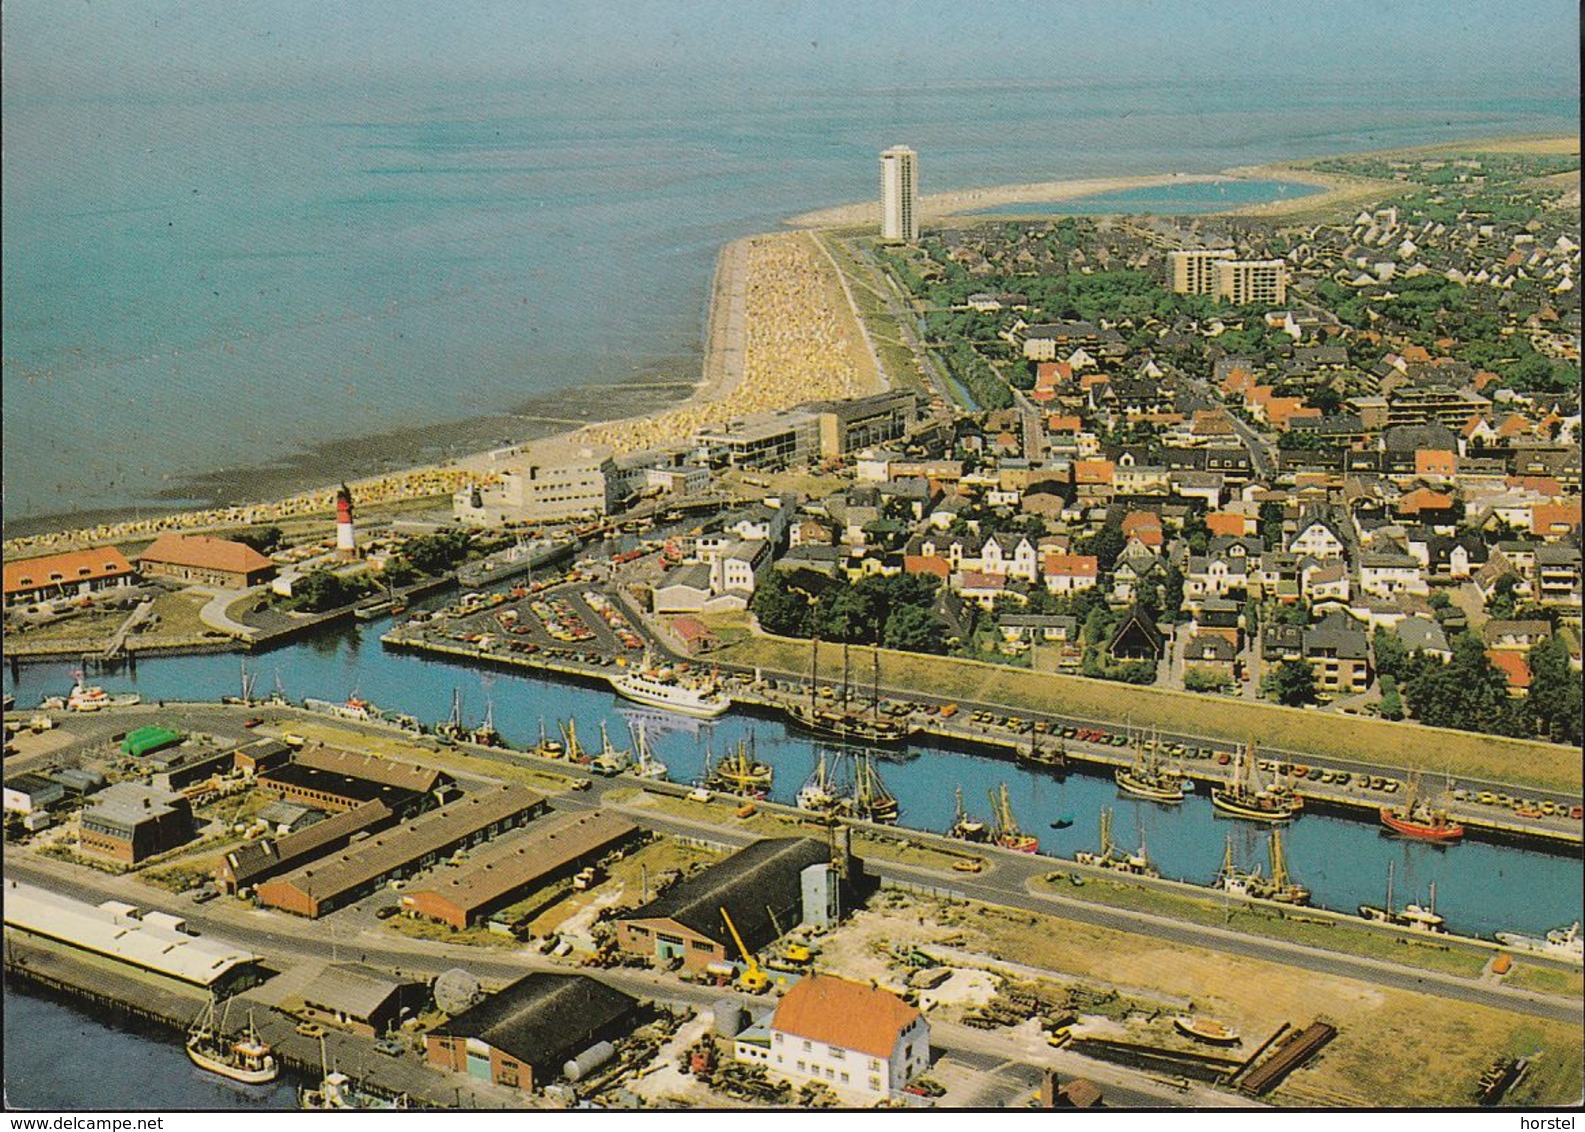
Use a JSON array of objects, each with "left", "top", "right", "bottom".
[{"left": 401, "top": 813, "right": 640, "bottom": 931}]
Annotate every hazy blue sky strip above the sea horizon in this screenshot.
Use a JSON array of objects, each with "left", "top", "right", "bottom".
[{"left": 0, "top": 0, "right": 1579, "bottom": 98}]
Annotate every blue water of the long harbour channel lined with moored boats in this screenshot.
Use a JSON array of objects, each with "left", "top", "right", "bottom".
[{"left": 5, "top": 598, "right": 1585, "bottom": 939}]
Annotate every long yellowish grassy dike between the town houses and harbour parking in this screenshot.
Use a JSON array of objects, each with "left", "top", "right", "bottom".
[{"left": 718, "top": 636, "right": 1582, "bottom": 794}]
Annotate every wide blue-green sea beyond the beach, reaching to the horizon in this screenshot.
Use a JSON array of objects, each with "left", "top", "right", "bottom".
[{"left": 0, "top": 73, "right": 1577, "bottom": 522}]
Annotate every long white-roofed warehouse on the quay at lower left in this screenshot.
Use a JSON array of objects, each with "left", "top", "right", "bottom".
[{"left": 3, "top": 880, "right": 263, "bottom": 989}]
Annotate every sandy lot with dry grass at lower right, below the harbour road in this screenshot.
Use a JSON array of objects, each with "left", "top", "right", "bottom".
[{"left": 823, "top": 894, "right": 1585, "bottom": 1107}]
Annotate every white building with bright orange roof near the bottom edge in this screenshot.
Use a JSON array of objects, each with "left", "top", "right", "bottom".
[{"left": 735, "top": 975, "right": 930, "bottom": 1100}]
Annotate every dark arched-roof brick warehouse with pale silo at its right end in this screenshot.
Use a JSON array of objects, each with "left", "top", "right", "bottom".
[{"left": 617, "top": 837, "right": 867, "bottom": 972}]
